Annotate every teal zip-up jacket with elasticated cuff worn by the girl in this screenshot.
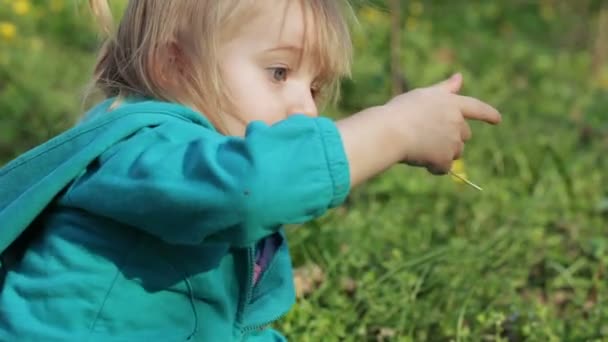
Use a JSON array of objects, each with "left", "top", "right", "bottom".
[{"left": 0, "top": 100, "right": 350, "bottom": 341}]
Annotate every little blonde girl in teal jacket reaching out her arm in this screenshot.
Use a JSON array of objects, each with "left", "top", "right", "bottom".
[{"left": 0, "top": 0, "right": 500, "bottom": 341}]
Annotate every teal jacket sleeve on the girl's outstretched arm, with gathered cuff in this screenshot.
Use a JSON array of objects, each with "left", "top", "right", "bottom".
[{"left": 63, "top": 115, "right": 350, "bottom": 246}]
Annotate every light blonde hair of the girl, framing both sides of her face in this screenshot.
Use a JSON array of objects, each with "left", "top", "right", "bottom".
[{"left": 89, "top": 0, "right": 354, "bottom": 132}]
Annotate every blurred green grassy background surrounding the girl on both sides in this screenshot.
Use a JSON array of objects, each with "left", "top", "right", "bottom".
[{"left": 0, "top": 0, "right": 608, "bottom": 341}]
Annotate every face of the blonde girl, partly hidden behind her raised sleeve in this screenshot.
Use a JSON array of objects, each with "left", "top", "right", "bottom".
[{"left": 219, "top": 0, "right": 318, "bottom": 135}]
